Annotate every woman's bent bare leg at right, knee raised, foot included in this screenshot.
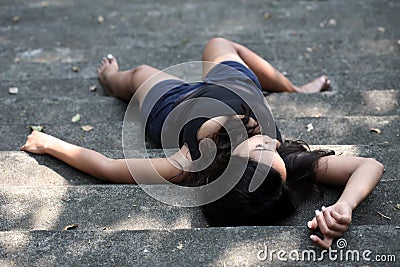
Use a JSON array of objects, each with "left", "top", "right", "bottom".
[{"left": 203, "top": 38, "right": 330, "bottom": 93}]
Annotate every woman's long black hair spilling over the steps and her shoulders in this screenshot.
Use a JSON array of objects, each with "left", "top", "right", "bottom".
[{"left": 188, "top": 107, "right": 334, "bottom": 226}]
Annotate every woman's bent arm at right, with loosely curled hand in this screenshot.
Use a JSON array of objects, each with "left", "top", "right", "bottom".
[{"left": 307, "top": 156, "right": 384, "bottom": 248}]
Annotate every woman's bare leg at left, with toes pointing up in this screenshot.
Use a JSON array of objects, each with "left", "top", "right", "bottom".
[{"left": 97, "top": 57, "right": 184, "bottom": 106}]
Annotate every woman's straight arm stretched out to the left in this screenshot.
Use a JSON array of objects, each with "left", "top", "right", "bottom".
[{"left": 21, "top": 131, "right": 186, "bottom": 184}]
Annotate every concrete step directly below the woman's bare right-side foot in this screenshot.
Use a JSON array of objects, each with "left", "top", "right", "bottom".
[{"left": 0, "top": 90, "right": 400, "bottom": 125}]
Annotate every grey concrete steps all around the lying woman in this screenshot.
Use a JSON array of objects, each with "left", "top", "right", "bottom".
[{"left": 0, "top": 0, "right": 400, "bottom": 266}]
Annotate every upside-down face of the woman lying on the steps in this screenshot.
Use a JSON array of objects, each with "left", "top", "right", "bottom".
[{"left": 233, "top": 135, "right": 286, "bottom": 181}]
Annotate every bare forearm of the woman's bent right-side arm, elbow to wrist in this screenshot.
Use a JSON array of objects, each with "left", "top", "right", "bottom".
[{"left": 337, "top": 159, "right": 384, "bottom": 209}]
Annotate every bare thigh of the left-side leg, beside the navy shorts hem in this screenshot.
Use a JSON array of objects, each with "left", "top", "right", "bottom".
[{"left": 131, "top": 65, "right": 181, "bottom": 106}]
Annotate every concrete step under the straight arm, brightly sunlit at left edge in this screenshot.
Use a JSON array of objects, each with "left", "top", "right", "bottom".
[{"left": 0, "top": 144, "right": 400, "bottom": 186}]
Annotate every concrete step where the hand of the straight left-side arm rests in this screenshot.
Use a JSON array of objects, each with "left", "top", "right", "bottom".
[{"left": 0, "top": 115, "right": 400, "bottom": 151}]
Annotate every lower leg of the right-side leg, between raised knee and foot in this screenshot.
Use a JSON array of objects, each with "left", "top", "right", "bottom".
[{"left": 232, "top": 42, "right": 296, "bottom": 92}]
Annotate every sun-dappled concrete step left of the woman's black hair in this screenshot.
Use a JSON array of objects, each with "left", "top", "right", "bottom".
[{"left": 0, "top": 185, "right": 207, "bottom": 230}]
